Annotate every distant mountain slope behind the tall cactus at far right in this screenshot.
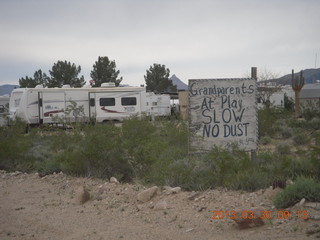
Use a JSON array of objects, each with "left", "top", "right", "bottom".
[{"left": 266, "top": 68, "right": 320, "bottom": 85}]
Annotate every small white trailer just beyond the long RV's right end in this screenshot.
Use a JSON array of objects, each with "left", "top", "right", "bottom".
[{"left": 147, "top": 92, "right": 171, "bottom": 116}]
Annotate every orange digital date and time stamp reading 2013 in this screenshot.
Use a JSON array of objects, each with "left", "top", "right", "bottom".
[{"left": 212, "top": 210, "right": 308, "bottom": 220}]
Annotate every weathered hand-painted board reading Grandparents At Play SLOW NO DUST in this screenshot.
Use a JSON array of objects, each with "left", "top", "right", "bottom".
[{"left": 189, "top": 78, "right": 258, "bottom": 152}]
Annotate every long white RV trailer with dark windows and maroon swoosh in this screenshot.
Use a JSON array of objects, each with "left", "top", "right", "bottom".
[{"left": 9, "top": 87, "right": 146, "bottom": 124}]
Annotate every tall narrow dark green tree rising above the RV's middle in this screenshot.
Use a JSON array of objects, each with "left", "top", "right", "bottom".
[{"left": 90, "top": 57, "right": 122, "bottom": 87}]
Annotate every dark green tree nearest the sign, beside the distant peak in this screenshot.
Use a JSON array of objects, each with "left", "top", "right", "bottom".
[{"left": 144, "top": 63, "right": 177, "bottom": 93}]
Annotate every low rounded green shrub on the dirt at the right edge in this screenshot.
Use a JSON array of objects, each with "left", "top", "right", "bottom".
[{"left": 273, "top": 177, "right": 320, "bottom": 208}]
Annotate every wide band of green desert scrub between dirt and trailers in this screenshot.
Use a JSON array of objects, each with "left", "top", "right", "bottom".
[{"left": 0, "top": 104, "right": 320, "bottom": 202}]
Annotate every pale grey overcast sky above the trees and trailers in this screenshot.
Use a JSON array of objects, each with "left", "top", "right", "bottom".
[{"left": 0, "top": 0, "right": 320, "bottom": 86}]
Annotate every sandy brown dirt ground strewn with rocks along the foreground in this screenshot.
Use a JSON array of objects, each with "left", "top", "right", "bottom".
[{"left": 0, "top": 171, "right": 320, "bottom": 240}]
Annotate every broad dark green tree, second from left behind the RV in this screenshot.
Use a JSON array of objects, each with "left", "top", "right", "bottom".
[{"left": 48, "top": 61, "right": 86, "bottom": 87}]
